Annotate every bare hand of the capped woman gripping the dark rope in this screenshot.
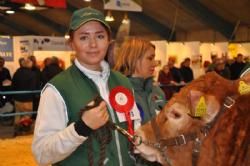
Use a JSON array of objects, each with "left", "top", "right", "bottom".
[{"left": 81, "top": 101, "right": 109, "bottom": 130}]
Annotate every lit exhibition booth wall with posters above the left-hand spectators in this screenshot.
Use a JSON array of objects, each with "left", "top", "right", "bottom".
[{"left": 0, "top": 36, "right": 73, "bottom": 75}]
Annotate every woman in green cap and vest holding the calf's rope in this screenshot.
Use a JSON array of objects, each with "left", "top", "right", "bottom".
[{"left": 32, "top": 7, "right": 140, "bottom": 166}]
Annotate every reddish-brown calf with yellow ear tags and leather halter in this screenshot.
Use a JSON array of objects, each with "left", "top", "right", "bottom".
[{"left": 136, "top": 73, "right": 250, "bottom": 166}]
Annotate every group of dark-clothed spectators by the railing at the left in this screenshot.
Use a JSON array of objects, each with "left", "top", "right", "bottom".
[{"left": 0, "top": 55, "right": 63, "bottom": 134}]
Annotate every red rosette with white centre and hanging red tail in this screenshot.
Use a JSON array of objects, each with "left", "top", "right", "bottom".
[{"left": 109, "top": 86, "right": 134, "bottom": 135}]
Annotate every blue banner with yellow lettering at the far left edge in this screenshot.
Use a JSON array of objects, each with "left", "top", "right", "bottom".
[{"left": 0, "top": 37, "right": 14, "bottom": 61}]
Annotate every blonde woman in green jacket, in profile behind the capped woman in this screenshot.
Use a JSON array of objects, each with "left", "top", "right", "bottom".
[{"left": 114, "top": 37, "right": 166, "bottom": 165}]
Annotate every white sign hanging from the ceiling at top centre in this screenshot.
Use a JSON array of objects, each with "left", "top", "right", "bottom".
[{"left": 104, "top": 0, "right": 142, "bottom": 12}]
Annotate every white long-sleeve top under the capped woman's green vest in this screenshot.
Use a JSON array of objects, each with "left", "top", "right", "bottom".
[{"left": 32, "top": 60, "right": 139, "bottom": 166}]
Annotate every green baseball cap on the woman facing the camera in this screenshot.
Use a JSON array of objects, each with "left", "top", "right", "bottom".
[{"left": 69, "top": 7, "right": 110, "bottom": 31}]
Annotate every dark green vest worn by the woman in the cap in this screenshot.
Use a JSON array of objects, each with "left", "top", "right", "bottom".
[{"left": 50, "top": 65, "right": 134, "bottom": 166}]
